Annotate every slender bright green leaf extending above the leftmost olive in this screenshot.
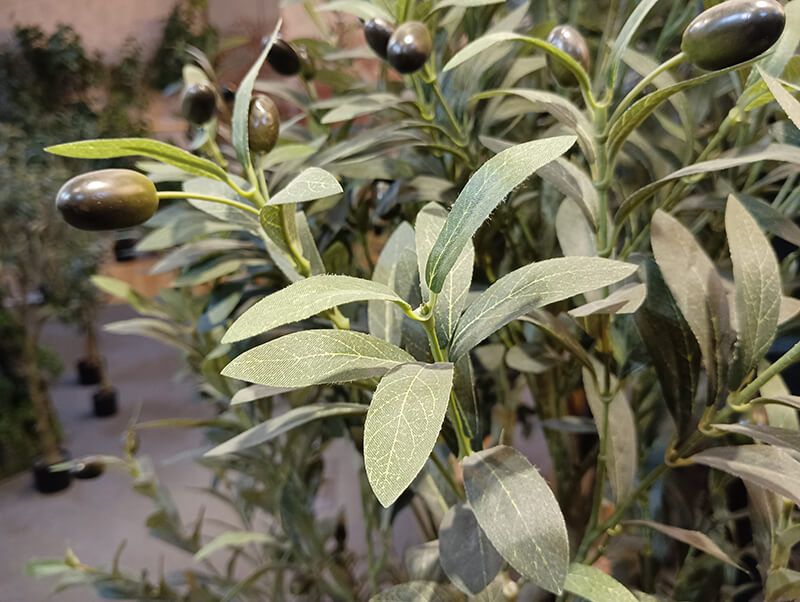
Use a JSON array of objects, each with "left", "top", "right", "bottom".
[{"left": 44, "top": 138, "right": 228, "bottom": 182}]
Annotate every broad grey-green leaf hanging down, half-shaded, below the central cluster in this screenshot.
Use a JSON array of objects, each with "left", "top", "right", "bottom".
[{"left": 462, "top": 445, "right": 569, "bottom": 594}]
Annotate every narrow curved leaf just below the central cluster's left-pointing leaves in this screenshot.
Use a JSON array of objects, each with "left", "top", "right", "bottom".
[{"left": 205, "top": 403, "right": 367, "bottom": 457}]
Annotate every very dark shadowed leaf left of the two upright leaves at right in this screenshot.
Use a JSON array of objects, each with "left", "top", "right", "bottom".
[{"left": 635, "top": 259, "right": 700, "bottom": 437}]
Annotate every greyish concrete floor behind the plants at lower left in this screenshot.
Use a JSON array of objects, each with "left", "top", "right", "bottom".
[{"left": 0, "top": 306, "right": 225, "bottom": 602}]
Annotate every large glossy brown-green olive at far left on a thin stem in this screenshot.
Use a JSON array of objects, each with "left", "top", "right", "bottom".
[{"left": 56, "top": 169, "right": 158, "bottom": 230}]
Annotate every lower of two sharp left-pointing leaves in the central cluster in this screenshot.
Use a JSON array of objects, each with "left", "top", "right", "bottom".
[{"left": 222, "top": 330, "right": 413, "bottom": 387}]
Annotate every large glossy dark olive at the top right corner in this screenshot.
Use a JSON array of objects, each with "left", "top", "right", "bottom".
[{"left": 681, "top": 0, "right": 786, "bottom": 71}]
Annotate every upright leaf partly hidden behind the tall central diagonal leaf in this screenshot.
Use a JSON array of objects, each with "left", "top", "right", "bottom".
[{"left": 416, "top": 203, "right": 475, "bottom": 347}]
